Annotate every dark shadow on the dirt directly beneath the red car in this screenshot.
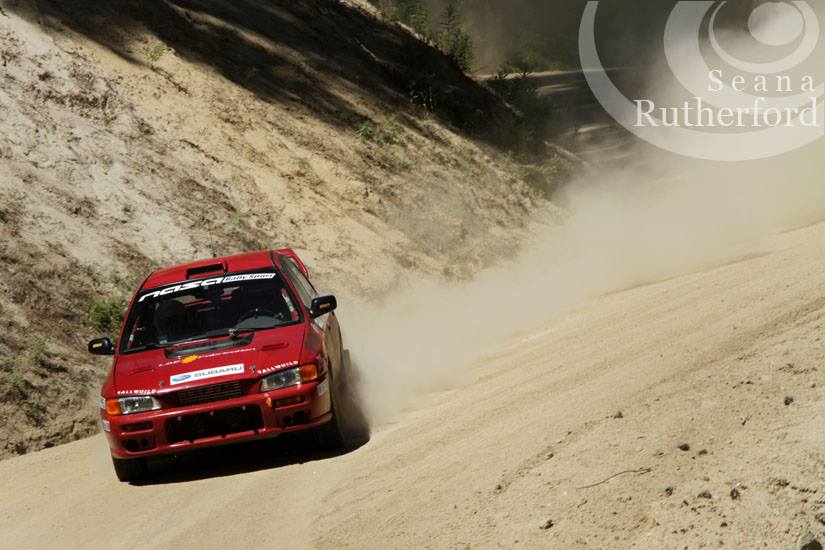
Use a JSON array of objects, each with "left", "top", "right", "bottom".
[{"left": 131, "top": 433, "right": 369, "bottom": 486}]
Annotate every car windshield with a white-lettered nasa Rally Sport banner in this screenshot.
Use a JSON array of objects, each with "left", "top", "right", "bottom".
[{"left": 120, "top": 272, "right": 300, "bottom": 353}]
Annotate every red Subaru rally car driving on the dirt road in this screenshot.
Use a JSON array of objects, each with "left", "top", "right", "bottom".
[{"left": 89, "top": 249, "right": 364, "bottom": 481}]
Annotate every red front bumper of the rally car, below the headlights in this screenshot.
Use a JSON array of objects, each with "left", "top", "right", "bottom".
[{"left": 101, "top": 379, "right": 332, "bottom": 458}]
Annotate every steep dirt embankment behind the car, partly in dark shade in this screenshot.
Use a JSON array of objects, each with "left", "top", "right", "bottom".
[{"left": 0, "top": 0, "right": 552, "bottom": 457}]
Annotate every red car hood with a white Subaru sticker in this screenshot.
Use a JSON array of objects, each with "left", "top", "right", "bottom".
[{"left": 109, "top": 323, "right": 305, "bottom": 396}]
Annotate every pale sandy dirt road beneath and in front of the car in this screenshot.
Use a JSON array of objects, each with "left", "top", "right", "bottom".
[{"left": 0, "top": 225, "right": 825, "bottom": 548}]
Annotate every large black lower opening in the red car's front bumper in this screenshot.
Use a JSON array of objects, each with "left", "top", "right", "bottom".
[{"left": 166, "top": 406, "right": 264, "bottom": 444}]
